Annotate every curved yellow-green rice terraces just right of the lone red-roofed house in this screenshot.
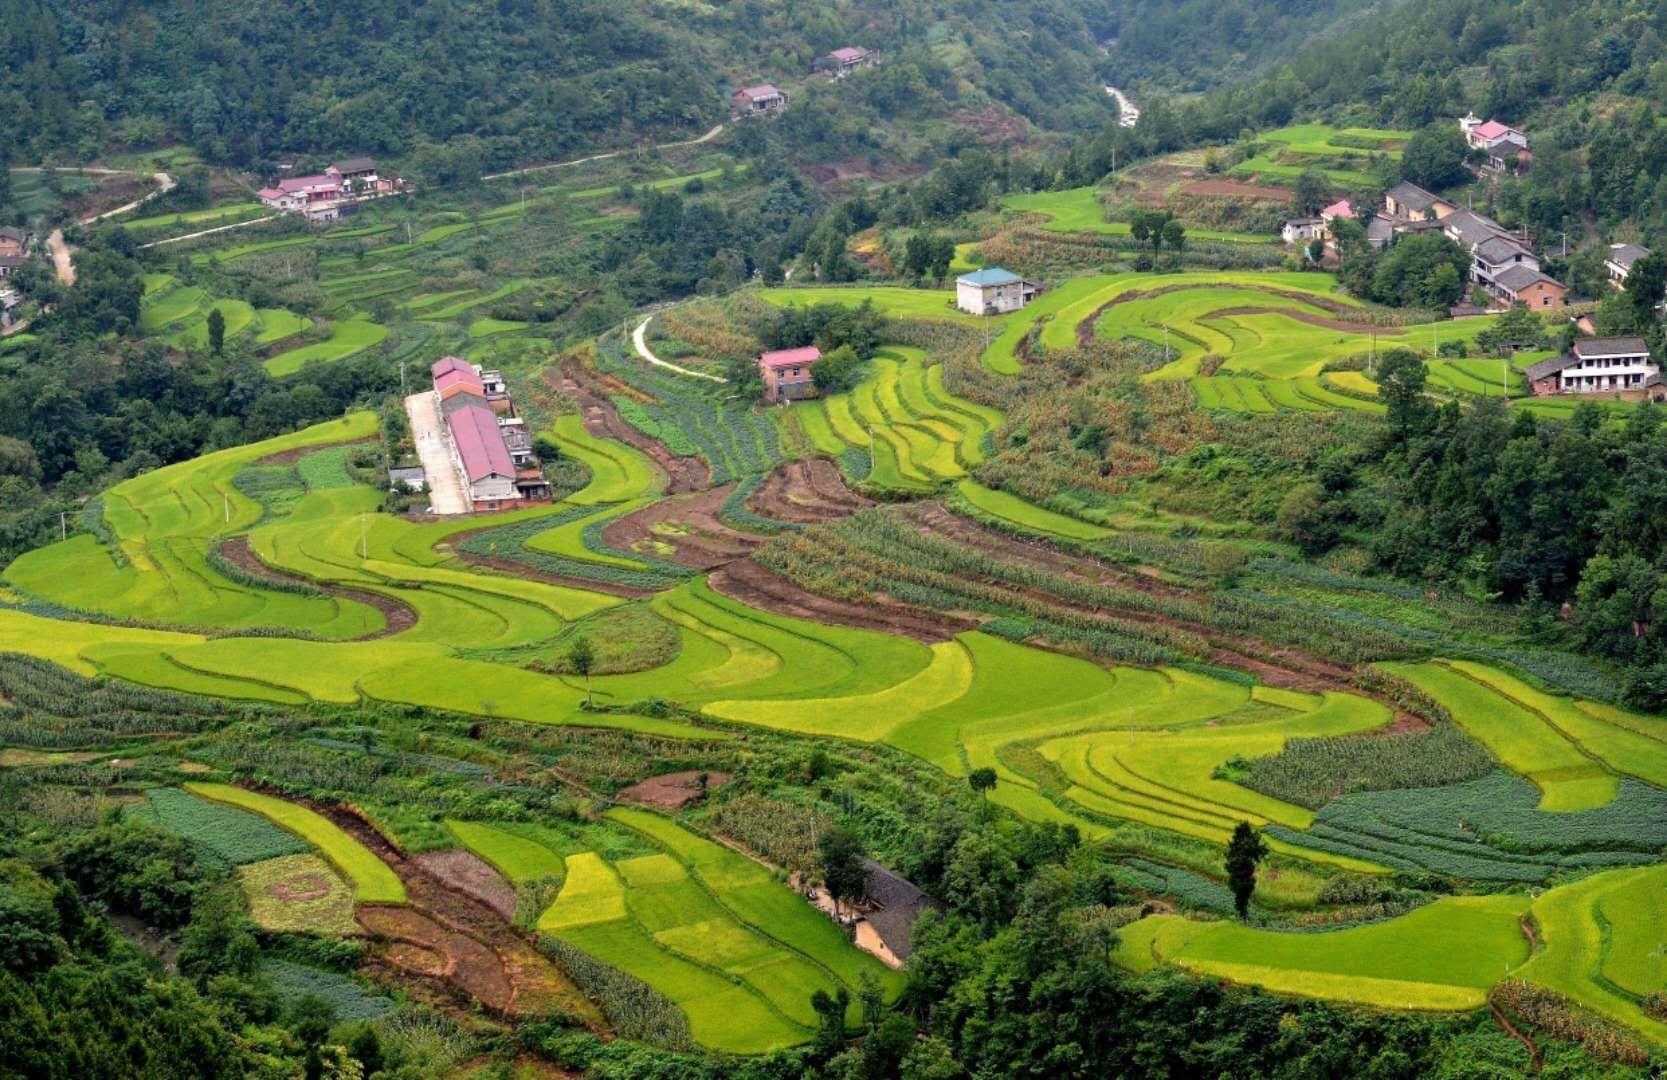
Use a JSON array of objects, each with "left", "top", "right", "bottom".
[{"left": 792, "top": 347, "right": 1002, "bottom": 493}]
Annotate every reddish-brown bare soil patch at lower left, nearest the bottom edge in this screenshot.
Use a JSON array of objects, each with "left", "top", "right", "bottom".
[{"left": 315, "top": 805, "right": 605, "bottom": 1030}]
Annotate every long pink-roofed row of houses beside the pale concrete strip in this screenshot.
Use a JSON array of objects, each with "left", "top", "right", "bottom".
[{"left": 406, "top": 357, "right": 550, "bottom": 512}]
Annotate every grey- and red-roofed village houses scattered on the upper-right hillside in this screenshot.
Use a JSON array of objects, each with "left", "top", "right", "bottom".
[{"left": 1280, "top": 115, "right": 1667, "bottom": 400}]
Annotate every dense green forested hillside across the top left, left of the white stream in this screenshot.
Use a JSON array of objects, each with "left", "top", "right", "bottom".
[{"left": 0, "top": 0, "right": 1105, "bottom": 167}]
